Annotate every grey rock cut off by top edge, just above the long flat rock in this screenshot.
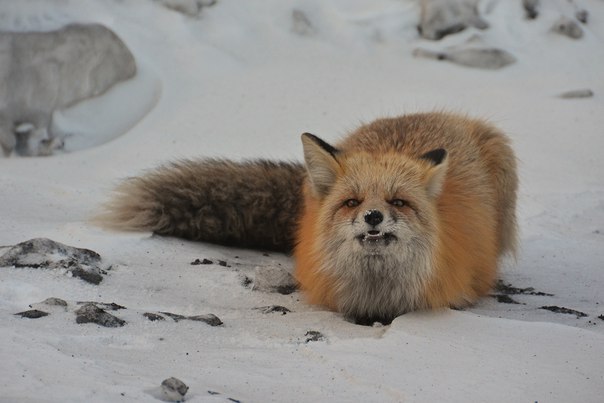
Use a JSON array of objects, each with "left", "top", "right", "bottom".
[{"left": 417, "top": 0, "right": 489, "bottom": 40}]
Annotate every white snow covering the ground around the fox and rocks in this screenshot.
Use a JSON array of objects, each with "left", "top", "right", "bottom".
[{"left": 0, "top": 0, "right": 604, "bottom": 402}]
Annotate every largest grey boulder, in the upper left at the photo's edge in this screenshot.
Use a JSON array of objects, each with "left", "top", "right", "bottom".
[{"left": 0, "top": 24, "right": 136, "bottom": 156}]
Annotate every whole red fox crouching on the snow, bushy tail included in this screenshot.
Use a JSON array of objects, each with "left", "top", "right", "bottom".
[{"left": 98, "top": 113, "right": 518, "bottom": 324}]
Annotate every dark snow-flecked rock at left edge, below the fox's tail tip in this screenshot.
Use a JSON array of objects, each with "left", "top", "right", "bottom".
[{"left": 0, "top": 238, "right": 109, "bottom": 284}]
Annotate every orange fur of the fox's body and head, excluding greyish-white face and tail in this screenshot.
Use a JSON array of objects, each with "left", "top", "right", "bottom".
[{"left": 294, "top": 113, "right": 517, "bottom": 320}]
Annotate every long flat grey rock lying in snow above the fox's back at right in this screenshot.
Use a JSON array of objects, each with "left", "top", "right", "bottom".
[{"left": 413, "top": 45, "right": 516, "bottom": 70}]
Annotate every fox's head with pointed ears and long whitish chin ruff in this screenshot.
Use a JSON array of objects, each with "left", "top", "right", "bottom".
[{"left": 302, "top": 133, "right": 447, "bottom": 322}]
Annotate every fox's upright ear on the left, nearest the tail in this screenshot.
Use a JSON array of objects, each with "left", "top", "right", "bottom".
[{"left": 302, "top": 133, "right": 339, "bottom": 197}]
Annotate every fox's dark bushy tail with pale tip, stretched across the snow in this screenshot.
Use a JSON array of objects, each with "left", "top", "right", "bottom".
[{"left": 94, "top": 159, "right": 305, "bottom": 252}]
